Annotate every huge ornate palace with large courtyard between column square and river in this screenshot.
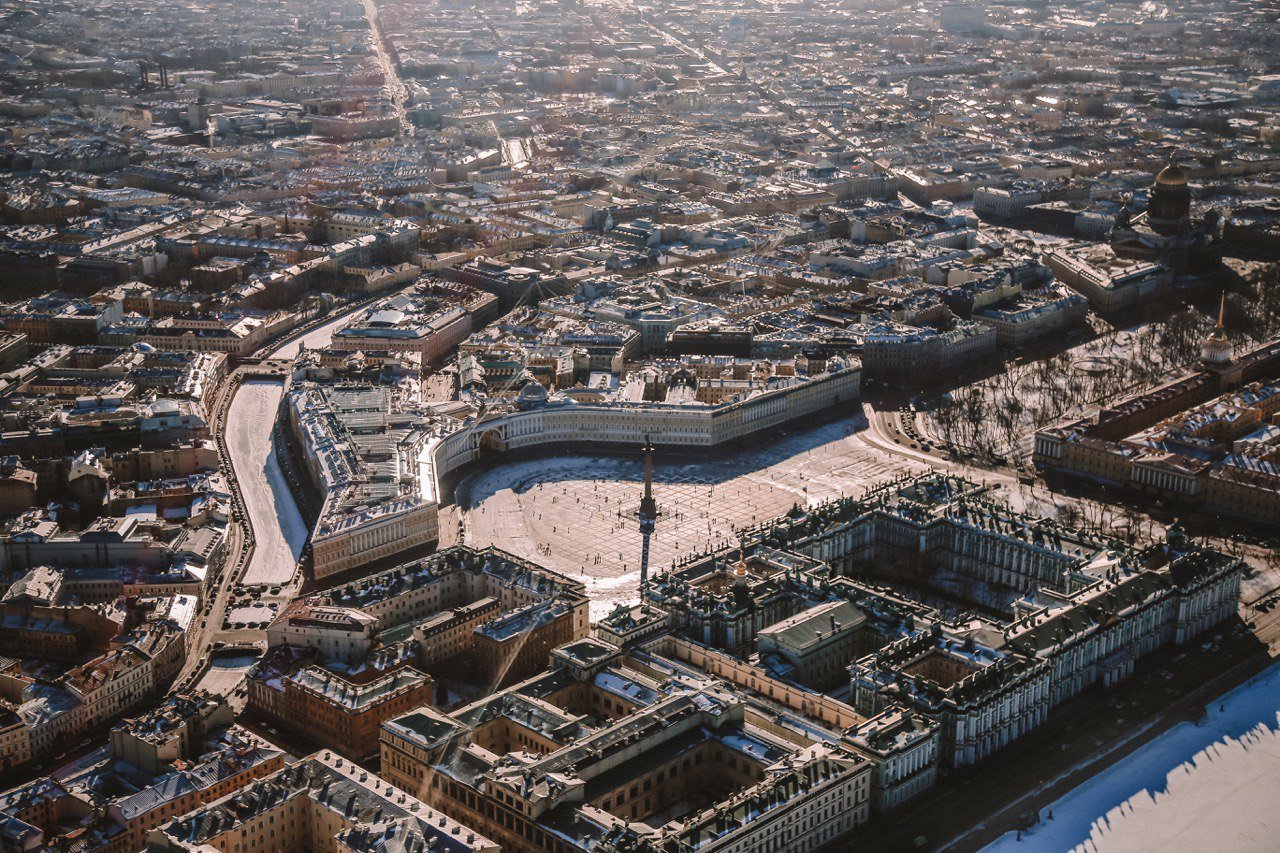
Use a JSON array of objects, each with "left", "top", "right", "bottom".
[{"left": 648, "top": 476, "right": 1242, "bottom": 763}]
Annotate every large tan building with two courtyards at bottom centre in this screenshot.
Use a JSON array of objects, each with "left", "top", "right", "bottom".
[{"left": 381, "top": 640, "right": 872, "bottom": 850}]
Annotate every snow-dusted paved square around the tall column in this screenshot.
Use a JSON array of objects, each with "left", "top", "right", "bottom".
[{"left": 457, "top": 416, "right": 924, "bottom": 617}]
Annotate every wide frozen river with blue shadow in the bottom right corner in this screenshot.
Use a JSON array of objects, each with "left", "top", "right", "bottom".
[{"left": 986, "top": 665, "right": 1280, "bottom": 853}]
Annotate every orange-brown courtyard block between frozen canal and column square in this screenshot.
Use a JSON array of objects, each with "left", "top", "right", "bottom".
[{"left": 256, "top": 547, "right": 589, "bottom": 760}]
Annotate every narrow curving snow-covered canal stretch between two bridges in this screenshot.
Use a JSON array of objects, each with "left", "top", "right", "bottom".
[{"left": 227, "top": 382, "right": 307, "bottom": 584}]
